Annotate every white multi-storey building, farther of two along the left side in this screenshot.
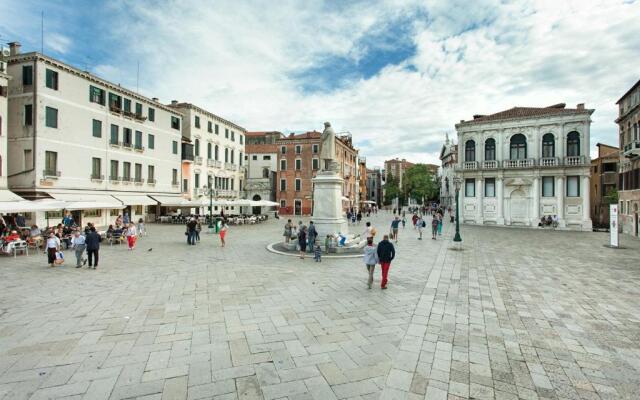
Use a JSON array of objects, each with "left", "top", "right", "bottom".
[{"left": 169, "top": 100, "right": 246, "bottom": 214}]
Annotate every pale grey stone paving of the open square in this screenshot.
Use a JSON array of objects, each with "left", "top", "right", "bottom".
[{"left": 0, "top": 213, "right": 640, "bottom": 400}]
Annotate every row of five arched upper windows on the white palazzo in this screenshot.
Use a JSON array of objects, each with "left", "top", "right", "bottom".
[{"left": 464, "top": 131, "right": 580, "bottom": 161}]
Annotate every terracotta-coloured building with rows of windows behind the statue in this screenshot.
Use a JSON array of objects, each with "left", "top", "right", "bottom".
[{"left": 276, "top": 131, "right": 358, "bottom": 215}]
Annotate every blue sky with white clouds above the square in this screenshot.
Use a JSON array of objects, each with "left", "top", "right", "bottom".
[{"left": 0, "top": 0, "right": 640, "bottom": 166}]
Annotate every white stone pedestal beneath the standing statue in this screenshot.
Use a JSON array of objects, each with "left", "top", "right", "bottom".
[{"left": 313, "top": 171, "right": 349, "bottom": 239}]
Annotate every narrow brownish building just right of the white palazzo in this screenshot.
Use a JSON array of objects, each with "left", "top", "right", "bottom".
[{"left": 589, "top": 143, "right": 620, "bottom": 228}]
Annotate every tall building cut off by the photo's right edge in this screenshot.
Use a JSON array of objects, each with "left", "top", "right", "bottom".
[{"left": 616, "top": 81, "right": 640, "bottom": 237}]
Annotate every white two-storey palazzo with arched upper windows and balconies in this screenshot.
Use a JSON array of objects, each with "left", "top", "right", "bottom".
[{"left": 456, "top": 104, "right": 594, "bottom": 230}]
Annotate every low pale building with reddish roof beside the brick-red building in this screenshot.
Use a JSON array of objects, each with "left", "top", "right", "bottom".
[{"left": 244, "top": 131, "right": 284, "bottom": 214}]
